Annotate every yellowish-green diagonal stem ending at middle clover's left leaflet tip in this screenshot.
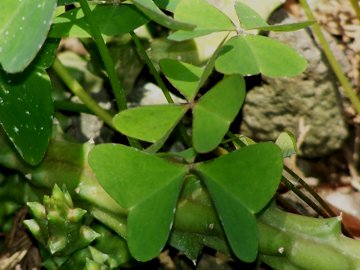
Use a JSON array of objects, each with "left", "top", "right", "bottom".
[{"left": 52, "top": 58, "right": 115, "bottom": 129}]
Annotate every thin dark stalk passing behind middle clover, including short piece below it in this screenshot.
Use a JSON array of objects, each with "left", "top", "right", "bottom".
[{"left": 130, "top": 31, "right": 191, "bottom": 147}]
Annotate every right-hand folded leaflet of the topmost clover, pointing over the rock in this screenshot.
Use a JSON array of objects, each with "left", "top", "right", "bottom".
[{"left": 235, "top": 1, "right": 314, "bottom": 32}]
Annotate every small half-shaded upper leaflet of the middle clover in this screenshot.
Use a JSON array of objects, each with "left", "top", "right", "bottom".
[{"left": 159, "top": 59, "right": 203, "bottom": 101}]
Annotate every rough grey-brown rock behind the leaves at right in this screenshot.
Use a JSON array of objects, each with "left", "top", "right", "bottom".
[{"left": 241, "top": 11, "right": 348, "bottom": 158}]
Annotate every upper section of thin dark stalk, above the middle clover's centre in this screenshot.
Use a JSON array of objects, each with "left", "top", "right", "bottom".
[{"left": 130, "top": 31, "right": 174, "bottom": 103}]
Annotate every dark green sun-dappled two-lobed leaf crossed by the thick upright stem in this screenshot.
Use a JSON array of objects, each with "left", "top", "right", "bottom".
[{"left": 49, "top": 4, "right": 149, "bottom": 37}]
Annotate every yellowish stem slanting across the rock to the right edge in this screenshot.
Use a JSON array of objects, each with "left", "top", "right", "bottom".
[{"left": 300, "top": 0, "right": 360, "bottom": 114}]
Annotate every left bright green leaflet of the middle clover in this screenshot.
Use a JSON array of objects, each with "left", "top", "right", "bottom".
[{"left": 113, "top": 104, "right": 187, "bottom": 143}]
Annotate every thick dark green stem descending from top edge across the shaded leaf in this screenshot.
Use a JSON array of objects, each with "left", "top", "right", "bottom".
[{"left": 79, "top": 0, "right": 127, "bottom": 111}]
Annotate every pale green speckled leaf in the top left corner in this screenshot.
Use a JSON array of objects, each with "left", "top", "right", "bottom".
[{"left": 0, "top": 0, "right": 56, "bottom": 73}]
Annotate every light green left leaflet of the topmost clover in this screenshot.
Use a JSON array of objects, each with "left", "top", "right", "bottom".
[{"left": 168, "top": 0, "right": 236, "bottom": 41}]
